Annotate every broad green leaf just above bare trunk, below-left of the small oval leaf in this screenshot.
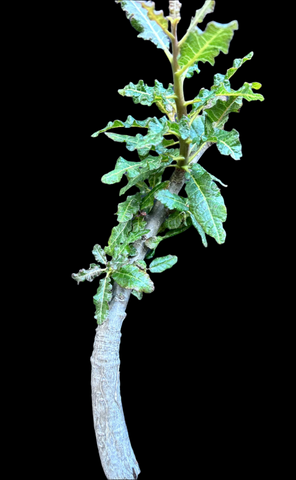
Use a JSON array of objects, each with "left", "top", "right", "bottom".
[{"left": 112, "top": 265, "right": 154, "bottom": 293}]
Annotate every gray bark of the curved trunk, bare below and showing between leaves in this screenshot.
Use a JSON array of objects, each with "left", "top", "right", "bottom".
[{"left": 91, "top": 142, "right": 212, "bottom": 480}]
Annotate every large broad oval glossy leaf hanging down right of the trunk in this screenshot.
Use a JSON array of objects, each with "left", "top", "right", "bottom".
[{"left": 185, "top": 164, "right": 226, "bottom": 244}]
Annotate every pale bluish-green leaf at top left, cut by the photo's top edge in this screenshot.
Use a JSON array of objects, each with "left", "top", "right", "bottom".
[{"left": 115, "top": 0, "right": 170, "bottom": 51}]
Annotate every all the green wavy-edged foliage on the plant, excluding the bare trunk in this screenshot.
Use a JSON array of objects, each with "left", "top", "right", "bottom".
[{"left": 72, "top": 0, "right": 264, "bottom": 324}]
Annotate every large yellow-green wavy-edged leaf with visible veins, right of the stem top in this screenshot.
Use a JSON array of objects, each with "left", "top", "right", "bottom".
[{"left": 178, "top": 20, "right": 238, "bottom": 75}]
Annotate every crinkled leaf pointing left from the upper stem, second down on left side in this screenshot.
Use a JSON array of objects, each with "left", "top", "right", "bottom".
[{"left": 118, "top": 80, "right": 176, "bottom": 121}]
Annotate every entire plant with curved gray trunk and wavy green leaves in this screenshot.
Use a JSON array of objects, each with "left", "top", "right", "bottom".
[{"left": 72, "top": 0, "right": 264, "bottom": 480}]
